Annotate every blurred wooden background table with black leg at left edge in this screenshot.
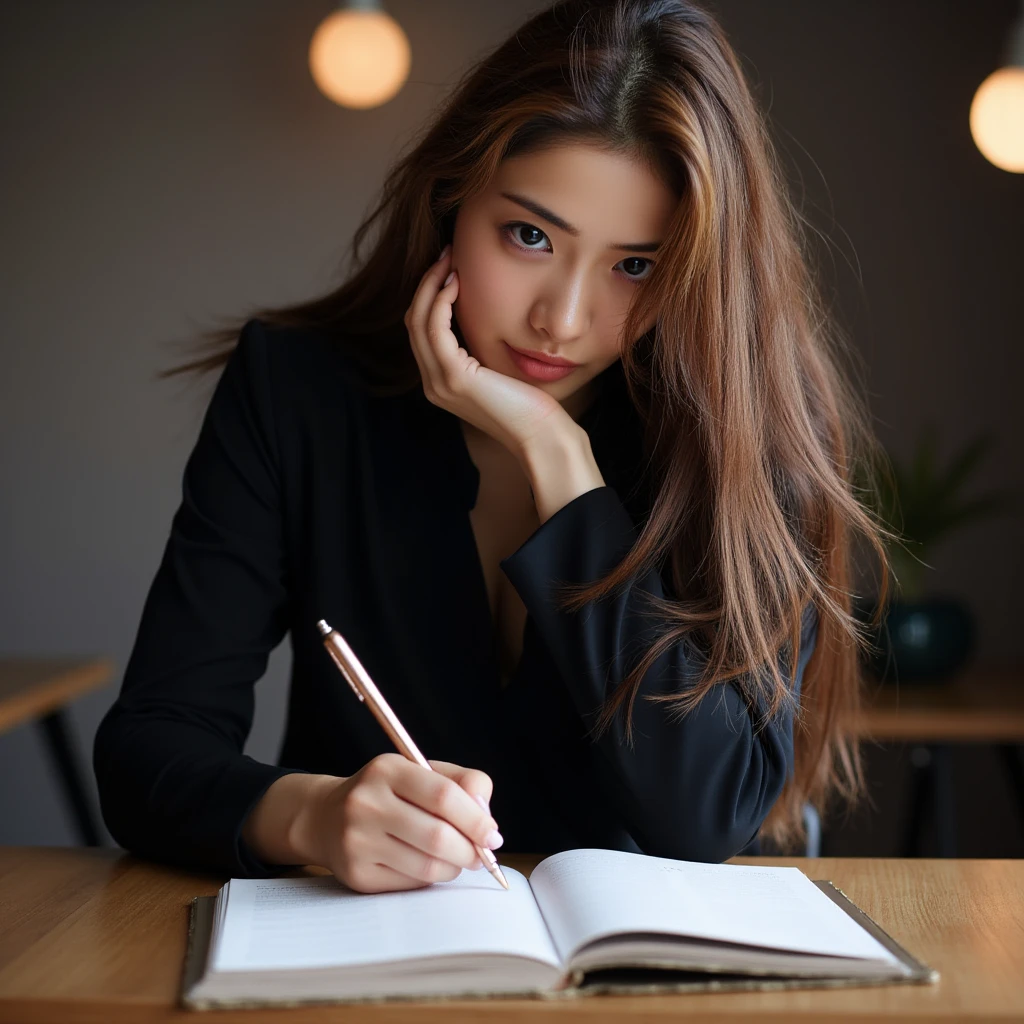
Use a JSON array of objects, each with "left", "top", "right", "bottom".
[{"left": 0, "top": 657, "right": 114, "bottom": 846}]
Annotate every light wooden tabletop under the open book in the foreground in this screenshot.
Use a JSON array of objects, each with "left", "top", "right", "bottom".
[{"left": 0, "top": 847, "right": 1024, "bottom": 1024}]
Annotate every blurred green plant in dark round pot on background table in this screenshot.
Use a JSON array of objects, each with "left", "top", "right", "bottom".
[{"left": 857, "top": 427, "right": 1014, "bottom": 682}]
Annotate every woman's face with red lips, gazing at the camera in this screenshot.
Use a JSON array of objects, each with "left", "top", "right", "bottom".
[{"left": 452, "top": 143, "right": 677, "bottom": 415}]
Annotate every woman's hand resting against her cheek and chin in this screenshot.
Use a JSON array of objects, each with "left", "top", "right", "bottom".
[{"left": 404, "top": 246, "right": 581, "bottom": 458}]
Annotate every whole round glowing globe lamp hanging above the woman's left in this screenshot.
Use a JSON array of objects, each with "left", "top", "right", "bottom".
[{"left": 309, "top": 2, "right": 411, "bottom": 110}]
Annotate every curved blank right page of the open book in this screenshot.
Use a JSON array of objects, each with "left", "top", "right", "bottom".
[{"left": 529, "top": 850, "right": 898, "bottom": 964}]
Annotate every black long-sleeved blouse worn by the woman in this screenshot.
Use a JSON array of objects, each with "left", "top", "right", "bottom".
[{"left": 93, "top": 321, "right": 817, "bottom": 877}]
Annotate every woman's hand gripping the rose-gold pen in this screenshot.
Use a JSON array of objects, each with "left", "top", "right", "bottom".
[{"left": 307, "top": 754, "right": 502, "bottom": 893}]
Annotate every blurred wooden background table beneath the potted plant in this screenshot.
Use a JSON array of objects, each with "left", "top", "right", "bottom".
[{"left": 849, "top": 666, "right": 1024, "bottom": 857}]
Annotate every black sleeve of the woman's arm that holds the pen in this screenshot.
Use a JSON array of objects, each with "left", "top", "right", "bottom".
[{"left": 93, "top": 321, "right": 303, "bottom": 877}]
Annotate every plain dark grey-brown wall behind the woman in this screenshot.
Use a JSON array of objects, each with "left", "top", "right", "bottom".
[{"left": 0, "top": 0, "right": 1024, "bottom": 856}]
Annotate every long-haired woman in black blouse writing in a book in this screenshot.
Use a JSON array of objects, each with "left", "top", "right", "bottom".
[{"left": 94, "top": 0, "right": 887, "bottom": 892}]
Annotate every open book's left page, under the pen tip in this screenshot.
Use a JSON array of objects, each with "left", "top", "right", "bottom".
[{"left": 213, "top": 867, "right": 559, "bottom": 971}]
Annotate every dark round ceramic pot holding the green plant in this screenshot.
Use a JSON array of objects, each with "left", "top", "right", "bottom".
[{"left": 858, "top": 597, "right": 976, "bottom": 683}]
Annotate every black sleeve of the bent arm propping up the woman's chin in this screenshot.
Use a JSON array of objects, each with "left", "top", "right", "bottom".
[{"left": 502, "top": 486, "right": 817, "bottom": 863}]
